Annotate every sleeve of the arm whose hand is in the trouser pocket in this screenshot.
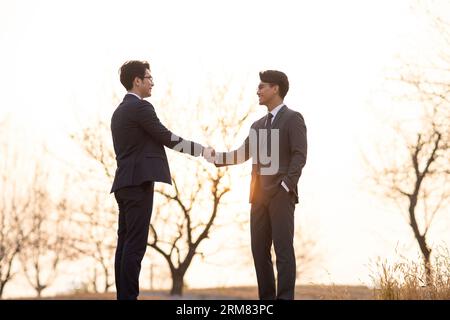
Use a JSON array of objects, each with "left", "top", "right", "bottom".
[{"left": 282, "top": 112, "right": 308, "bottom": 190}]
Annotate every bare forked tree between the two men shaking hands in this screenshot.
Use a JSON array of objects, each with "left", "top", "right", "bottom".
[{"left": 148, "top": 85, "right": 260, "bottom": 295}]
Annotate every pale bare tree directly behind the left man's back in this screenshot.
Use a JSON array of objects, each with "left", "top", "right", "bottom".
[{"left": 72, "top": 120, "right": 117, "bottom": 292}]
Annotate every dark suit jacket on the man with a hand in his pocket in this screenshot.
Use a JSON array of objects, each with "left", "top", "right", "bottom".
[{"left": 216, "top": 106, "right": 307, "bottom": 203}]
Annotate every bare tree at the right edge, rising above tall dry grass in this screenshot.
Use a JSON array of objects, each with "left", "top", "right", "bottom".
[{"left": 366, "top": 1, "right": 450, "bottom": 283}]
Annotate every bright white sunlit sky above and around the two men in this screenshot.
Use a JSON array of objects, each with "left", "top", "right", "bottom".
[{"left": 0, "top": 0, "right": 449, "bottom": 296}]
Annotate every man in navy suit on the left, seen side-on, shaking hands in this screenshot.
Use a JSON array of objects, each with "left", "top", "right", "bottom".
[{"left": 111, "top": 61, "right": 211, "bottom": 300}]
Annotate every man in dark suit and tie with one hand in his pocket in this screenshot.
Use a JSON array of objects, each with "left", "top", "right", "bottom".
[{"left": 209, "top": 70, "right": 307, "bottom": 300}]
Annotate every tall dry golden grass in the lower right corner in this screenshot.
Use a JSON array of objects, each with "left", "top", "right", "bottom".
[{"left": 372, "top": 249, "right": 450, "bottom": 300}]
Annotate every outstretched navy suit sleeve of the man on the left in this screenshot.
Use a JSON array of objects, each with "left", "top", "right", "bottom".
[{"left": 136, "top": 100, "right": 203, "bottom": 157}]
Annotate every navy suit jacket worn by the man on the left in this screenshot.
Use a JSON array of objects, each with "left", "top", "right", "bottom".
[{"left": 111, "top": 94, "right": 203, "bottom": 192}]
